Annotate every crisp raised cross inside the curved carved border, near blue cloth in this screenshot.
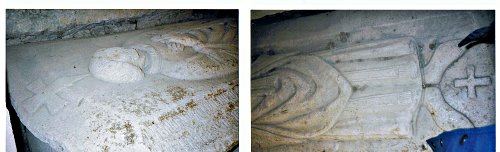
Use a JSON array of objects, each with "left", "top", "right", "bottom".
[{"left": 455, "top": 65, "right": 491, "bottom": 98}]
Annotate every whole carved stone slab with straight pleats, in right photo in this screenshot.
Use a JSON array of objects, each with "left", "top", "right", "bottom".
[{"left": 251, "top": 11, "right": 495, "bottom": 151}]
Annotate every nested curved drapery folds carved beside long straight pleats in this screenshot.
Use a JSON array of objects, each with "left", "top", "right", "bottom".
[{"left": 252, "top": 56, "right": 352, "bottom": 138}]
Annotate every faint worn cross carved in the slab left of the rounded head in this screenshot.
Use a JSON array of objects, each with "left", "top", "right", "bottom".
[{"left": 23, "top": 74, "right": 87, "bottom": 114}]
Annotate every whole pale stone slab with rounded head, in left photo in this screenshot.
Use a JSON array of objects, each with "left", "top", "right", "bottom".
[{"left": 7, "top": 19, "right": 238, "bottom": 151}]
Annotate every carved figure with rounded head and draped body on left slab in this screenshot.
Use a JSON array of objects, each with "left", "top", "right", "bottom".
[{"left": 90, "top": 22, "right": 238, "bottom": 83}]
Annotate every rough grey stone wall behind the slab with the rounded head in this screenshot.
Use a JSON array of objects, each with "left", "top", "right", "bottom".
[{"left": 6, "top": 9, "right": 237, "bottom": 46}]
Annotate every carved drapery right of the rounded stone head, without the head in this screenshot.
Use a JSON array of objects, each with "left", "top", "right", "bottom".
[{"left": 123, "top": 24, "right": 238, "bottom": 81}]
